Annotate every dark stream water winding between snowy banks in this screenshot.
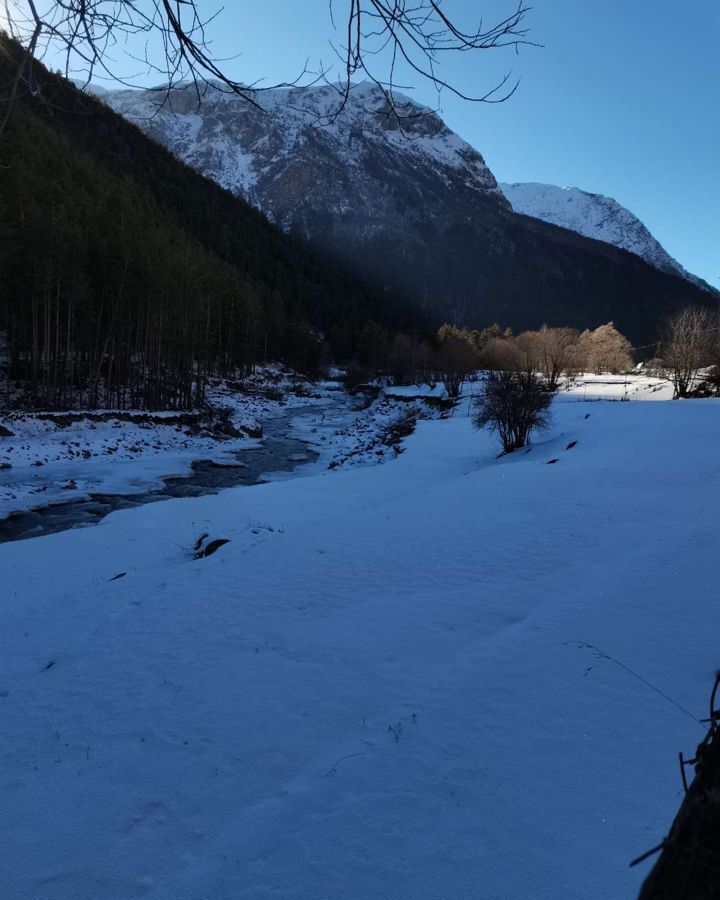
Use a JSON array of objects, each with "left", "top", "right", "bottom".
[{"left": 0, "top": 406, "right": 319, "bottom": 543}]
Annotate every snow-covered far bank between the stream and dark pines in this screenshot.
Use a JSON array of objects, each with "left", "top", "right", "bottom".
[{"left": 0, "top": 368, "right": 320, "bottom": 519}]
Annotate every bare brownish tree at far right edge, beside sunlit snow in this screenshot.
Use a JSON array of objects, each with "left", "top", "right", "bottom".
[{"left": 661, "top": 306, "right": 720, "bottom": 399}]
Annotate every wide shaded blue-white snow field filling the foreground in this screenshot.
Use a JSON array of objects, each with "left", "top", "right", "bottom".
[{"left": 0, "top": 376, "right": 720, "bottom": 900}]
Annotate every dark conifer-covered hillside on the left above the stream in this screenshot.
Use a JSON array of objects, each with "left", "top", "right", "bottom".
[{"left": 0, "top": 37, "right": 417, "bottom": 408}]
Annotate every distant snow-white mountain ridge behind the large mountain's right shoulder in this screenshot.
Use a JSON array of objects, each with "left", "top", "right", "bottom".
[{"left": 500, "top": 182, "right": 709, "bottom": 289}]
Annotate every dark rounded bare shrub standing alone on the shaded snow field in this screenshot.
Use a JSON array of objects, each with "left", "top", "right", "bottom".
[{"left": 473, "top": 372, "right": 553, "bottom": 453}]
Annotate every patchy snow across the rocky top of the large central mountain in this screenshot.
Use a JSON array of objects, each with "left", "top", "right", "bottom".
[{"left": 102, "top": 82, "right": 504, "bottom": 203}]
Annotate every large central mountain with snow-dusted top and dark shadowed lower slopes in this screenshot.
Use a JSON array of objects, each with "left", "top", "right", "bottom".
[{"left": 105, "top": 84, "right": 709, "bottom": 342}]
